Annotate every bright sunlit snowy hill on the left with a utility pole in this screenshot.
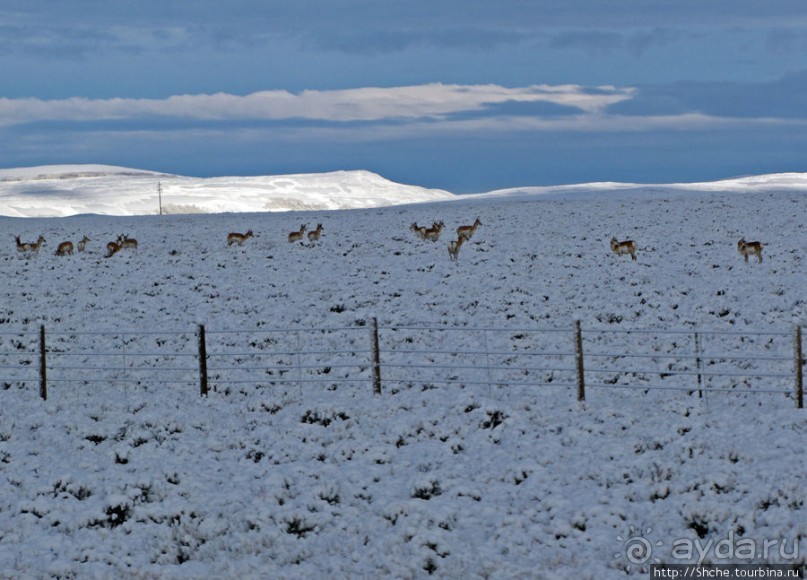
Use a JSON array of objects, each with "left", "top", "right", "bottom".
[{"left": 0, "top": 165, "right": 454, "bottom": 217}]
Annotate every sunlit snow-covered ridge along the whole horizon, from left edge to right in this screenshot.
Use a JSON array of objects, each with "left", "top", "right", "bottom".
[{"left": 0, "top": 165, "right": 807, "bottom": 217}]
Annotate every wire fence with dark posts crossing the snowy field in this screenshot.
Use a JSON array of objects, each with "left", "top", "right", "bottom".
[{"left": 0, "top": 319, "right": 805, "bottom": 409}]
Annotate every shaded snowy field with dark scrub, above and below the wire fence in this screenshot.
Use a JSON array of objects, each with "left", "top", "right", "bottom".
[{"left": 0, "top": 167, "right": 807, "bottom": 578}]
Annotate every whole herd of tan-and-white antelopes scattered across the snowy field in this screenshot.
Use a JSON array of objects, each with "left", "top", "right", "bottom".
[{"left": 9, "top": 217, "right": 765, "bottom": 263}]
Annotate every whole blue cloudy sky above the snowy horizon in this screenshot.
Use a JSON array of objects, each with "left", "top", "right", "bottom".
[{"left": 0, "top": 0, "right": 807, "bottom": 193}]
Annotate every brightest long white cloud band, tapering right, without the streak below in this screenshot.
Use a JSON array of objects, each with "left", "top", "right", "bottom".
[{"left": 0, "top": 83, "right": 633, "bottom": 125}]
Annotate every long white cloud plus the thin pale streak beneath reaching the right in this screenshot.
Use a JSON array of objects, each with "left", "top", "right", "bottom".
[{"left": 0, "top": 84, "right": 802, "bottom": 147}]
